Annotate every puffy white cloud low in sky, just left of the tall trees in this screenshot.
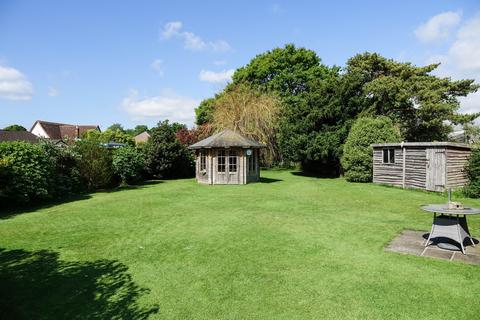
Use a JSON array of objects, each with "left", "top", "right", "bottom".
[{"left": 122, "top": 90, "right": 200, "bottom": 125}]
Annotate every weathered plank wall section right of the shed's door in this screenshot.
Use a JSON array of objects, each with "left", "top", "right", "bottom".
[{"left": 446, "top": 148, "right": 471, "bottom": 188}]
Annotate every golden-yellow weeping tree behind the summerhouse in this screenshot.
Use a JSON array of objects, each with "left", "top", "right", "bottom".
[{"left": 212, "top": 85, "right": 281, "bottom": 166}]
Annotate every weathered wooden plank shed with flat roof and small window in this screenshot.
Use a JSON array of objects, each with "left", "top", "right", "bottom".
[{"left": 372, "top": 142, "right": 471, "bottom": 191}]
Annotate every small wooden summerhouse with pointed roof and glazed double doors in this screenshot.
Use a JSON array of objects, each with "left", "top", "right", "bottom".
[{"left": 189, "top": 129, "right": 265, "bottom": 184}]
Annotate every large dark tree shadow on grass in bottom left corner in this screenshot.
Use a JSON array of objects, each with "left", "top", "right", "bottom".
[{"left": 0, "top": 249, "right": 158, "bottom": 319}]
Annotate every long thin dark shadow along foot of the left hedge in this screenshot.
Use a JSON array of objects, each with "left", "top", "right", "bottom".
[{"left": 0, "top": 180, "right": 162, "bottom": 220}]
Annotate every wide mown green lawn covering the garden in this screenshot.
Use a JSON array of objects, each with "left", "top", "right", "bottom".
[{"left": 0, "top": 171, "right": 480, "bottom": 319}]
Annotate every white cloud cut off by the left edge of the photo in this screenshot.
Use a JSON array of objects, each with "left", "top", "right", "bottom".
[{"left": 0, "top": 66, "right": 33, "bottom": 100}]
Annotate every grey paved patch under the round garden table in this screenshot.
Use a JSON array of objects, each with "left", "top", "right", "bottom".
[{"left": 385, "top": 230, "right": 480, "bottom": 264}]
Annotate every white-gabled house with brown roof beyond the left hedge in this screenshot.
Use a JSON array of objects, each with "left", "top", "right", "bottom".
[{"left": 30, "top": 120, "right": 100, "bottom": 141}]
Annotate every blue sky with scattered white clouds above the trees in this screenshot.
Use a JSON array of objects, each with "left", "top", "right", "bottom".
[{"left": 0, "top": 0, "right": 480, "bottom": 129}]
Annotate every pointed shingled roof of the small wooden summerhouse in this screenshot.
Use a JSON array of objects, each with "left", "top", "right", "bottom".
[{"left": 188, "top": 129, "right": 265, "bottom": 149}]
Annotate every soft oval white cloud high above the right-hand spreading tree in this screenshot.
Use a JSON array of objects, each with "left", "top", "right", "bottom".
[{"left": 415, "top": 11, "right": 462, "bottom": 42}]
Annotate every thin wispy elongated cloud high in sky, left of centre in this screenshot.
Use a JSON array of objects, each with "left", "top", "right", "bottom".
[{"left": 160, "top": 21, "right": 232, "bottom": 52}]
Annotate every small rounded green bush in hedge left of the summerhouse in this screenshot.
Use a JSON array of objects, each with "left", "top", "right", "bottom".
[{"left": 112, "top": 147, "right": 145, "bottom": 184}]
